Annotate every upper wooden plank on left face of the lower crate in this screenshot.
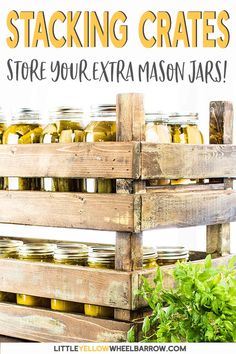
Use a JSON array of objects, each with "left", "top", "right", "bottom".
[{"left": 0, "top": 259, "right": 131, "bottom": 309}]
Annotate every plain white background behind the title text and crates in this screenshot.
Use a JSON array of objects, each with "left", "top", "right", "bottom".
[{"left": 0, "top": 0, "right": 236, "bottom": 252}]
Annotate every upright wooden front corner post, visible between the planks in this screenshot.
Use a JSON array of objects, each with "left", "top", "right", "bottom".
[{"left": 114, "top": 94, "right": 145, "bottom": 320}]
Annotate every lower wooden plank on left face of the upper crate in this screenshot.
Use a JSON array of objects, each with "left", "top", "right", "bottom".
[{"left": 0, "top": 191, "right": 134, "bottom": 231}]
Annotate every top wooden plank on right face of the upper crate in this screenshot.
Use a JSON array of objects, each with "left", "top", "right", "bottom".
[{"left": 141, "top": 143, "right": 236, "bottom": 179}]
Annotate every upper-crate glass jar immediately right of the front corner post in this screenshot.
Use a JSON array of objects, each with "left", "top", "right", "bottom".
[{"left": 145, "top": 112, "right": 172, "bottom": 186}]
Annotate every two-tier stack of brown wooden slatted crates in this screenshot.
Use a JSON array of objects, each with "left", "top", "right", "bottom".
[{"left": 0, "top": 94, "right": 236, "bottom": 342}]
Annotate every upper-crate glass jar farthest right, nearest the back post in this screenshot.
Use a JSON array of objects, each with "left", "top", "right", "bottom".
[{"left": 169, "top": 113, "right": 204, "bottom": 185}]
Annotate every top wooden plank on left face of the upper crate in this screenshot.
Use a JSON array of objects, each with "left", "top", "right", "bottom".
[{"left": 0, "top": 142, "right": 140, "bottom": 178}]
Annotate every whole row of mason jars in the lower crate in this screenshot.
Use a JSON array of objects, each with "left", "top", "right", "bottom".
[{"left": 0, "top": 239, "right": 189, "bottom": 318}]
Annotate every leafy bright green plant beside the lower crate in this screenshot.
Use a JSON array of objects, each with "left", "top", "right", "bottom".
[{"left": 128, "top": 256, "right": 236, "bottom": 342}]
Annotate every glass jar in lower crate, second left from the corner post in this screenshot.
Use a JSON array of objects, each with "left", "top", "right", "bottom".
[{"left": 51, "top": 243, "right": 88, "bottom": 313}]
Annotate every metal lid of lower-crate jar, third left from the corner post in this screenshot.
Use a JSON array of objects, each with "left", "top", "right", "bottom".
[{"left": 19, "top": 242, "right": 56, "bottom": 257}]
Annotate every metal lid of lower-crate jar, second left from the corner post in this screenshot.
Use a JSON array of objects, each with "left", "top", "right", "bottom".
[{"left": 54, "top": 243, "right": 88, "bottom": 260}]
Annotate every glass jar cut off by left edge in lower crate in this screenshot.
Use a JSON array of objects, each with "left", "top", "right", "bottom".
[{"left": 0, "top": 239, "right": 23, "bottom": 302}]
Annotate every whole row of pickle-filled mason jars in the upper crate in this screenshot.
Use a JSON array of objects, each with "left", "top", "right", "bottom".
[{"left": 0, "top": 105, "right": 203, "bottom": 193}]
